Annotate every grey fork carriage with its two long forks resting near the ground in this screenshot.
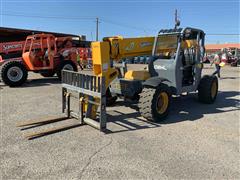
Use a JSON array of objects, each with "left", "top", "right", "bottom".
[{"left": 17, "top": 70, "right": 107, "bottom": 139}]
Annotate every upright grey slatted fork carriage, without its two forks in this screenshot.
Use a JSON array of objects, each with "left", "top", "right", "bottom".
[{"left": 62, "top": 70, "right": 107, "bottom": 131}]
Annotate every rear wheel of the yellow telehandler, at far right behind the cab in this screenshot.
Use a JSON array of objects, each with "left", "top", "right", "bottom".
[{"left": 198, "top": 75, "right": 218, "bottom": 104}]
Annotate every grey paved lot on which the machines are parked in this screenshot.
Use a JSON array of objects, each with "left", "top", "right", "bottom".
[{"left": 0, "top": 66, "right": 240, "bottom": 180}]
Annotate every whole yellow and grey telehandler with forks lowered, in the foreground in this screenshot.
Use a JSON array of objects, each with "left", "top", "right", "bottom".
[{"left": 19, "top": 27, "right": 218, "bottom": 138}]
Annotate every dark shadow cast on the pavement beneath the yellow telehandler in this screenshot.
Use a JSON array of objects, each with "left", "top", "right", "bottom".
[{"left": 107, "top": 91, "right": 240, "bottom": 133}]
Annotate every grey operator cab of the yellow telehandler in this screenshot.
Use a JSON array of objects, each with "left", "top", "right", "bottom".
[{"left": 149, "top": 28, "right": 204, "bottom": 94}]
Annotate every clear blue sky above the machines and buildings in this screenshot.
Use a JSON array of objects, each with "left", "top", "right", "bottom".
[{"left": 0, "top": 0, "right": 240, "bottom": 43}]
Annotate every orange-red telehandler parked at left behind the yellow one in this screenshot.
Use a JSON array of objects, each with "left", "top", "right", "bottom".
[{"left": 1, "top": 34, "right": 91, "bottom": 87}]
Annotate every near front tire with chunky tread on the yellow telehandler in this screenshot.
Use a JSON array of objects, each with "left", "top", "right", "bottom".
[{"left": 138, "top": 84, "right": 171, "bottom": 122}]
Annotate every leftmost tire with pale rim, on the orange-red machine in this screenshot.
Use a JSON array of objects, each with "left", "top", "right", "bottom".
[{"left": 1, "top": 61, "right": 28, "bottom": 87}]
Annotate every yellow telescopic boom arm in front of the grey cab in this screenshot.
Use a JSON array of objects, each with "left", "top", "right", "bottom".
[{"left": 91, "top": 36, "right": 154, "bottom": 87}]
